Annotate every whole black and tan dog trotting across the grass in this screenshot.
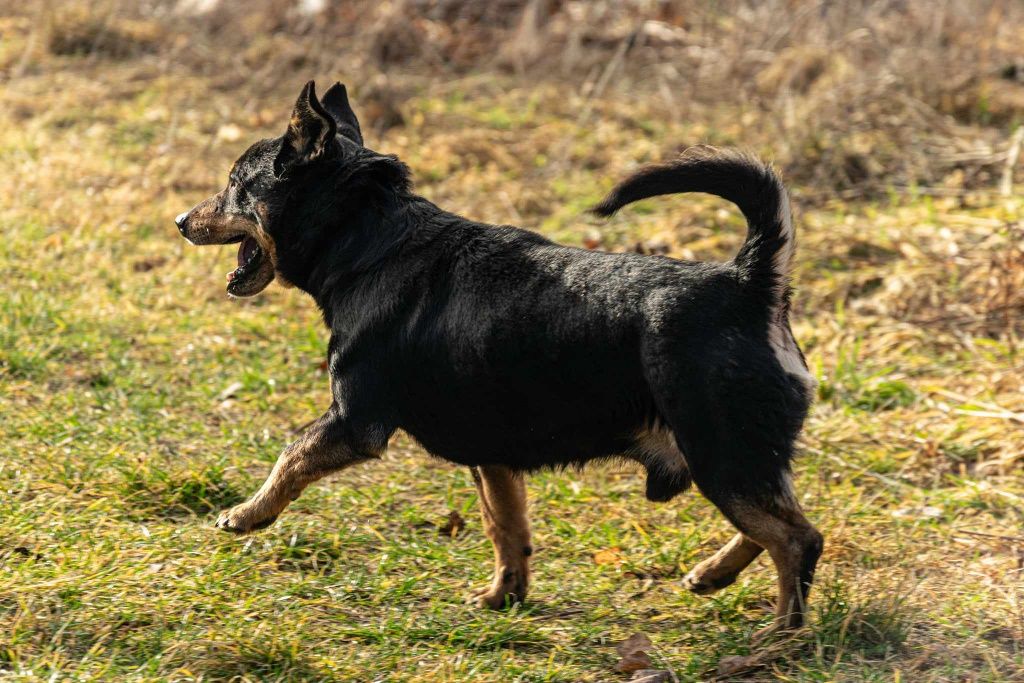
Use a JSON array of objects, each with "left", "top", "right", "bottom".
[{"left": 175, "top": 81, "right": 823, "bottom": 629}]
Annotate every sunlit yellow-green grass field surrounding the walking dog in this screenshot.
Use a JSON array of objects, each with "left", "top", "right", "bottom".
[{"left": 0, "top": 2, "right": 1024, "bottom": 682}]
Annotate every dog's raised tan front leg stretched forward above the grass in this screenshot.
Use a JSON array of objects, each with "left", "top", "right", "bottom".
[{"left": 217, "top": 404, "right": 386, "bottom": 533}]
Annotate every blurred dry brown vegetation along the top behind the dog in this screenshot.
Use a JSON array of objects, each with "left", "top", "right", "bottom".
[{"left": 9, "top": 0, "right": 1024, "bottom": 198}]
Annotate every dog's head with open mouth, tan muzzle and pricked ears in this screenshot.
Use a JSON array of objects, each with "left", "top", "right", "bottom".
[{"left": 174, "top": 81, "right": 362, "bottom": 297}]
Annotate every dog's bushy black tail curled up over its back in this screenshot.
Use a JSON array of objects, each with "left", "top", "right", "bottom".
[{"left": 594, "top": 145, "right": 796, "bottom": 299}]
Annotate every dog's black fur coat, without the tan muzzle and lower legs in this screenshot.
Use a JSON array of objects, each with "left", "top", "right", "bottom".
[{"left": 211, "top": 81, "right": 809, "bottom": 507}]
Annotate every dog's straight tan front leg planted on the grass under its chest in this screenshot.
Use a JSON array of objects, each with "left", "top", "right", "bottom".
[{"left": 471, "top": 465, "right": 534, "bottom": 609}]
